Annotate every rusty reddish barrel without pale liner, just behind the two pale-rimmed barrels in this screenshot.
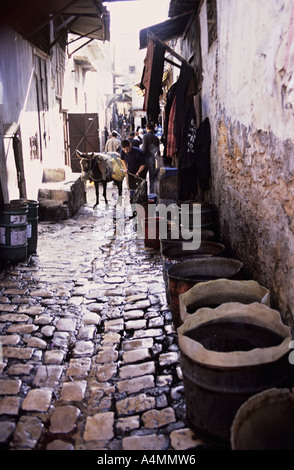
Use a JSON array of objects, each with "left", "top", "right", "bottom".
[{"left": 167, "top": 257, "right": 243, "bottom": 327}]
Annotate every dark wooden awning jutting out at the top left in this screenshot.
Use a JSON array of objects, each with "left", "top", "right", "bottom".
[{"left": 2, "top": 0, "right": 110, "bottom": 48}]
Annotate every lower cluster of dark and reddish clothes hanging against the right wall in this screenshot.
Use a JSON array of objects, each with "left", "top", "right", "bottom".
[{"left": 164, "top": 63, "right": 211, "bottom": 201}]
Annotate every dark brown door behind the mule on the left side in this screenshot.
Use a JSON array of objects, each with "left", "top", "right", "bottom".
[{"left": 68, "top": 114, "right": 100, "bottom": 173}]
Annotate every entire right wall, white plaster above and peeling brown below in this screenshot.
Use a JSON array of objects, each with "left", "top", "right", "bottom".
[{"left": 200, "top": 0, "right": 294, "bottom": 320}]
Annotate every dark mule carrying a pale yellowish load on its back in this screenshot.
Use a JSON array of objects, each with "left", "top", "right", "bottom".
[{"left": 76, "top": 150, "right": 125, "bottom": 209}]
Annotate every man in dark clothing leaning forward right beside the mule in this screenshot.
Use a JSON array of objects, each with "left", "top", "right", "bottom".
[{"left": 120, "top": 139, "right": 145, "bottom": 202}]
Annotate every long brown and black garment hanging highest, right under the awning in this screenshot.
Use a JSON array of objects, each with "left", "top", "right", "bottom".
[{"left": 140, "top": 38, "right": 165, "bottom": 124}]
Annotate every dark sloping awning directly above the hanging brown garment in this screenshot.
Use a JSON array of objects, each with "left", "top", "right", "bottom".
[{"left": 140, "top": 11, "right": 193, "bottom": 49}]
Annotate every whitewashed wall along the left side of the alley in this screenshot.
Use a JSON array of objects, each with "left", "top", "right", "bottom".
[{"left": 0, "top": 27, "right": 68, "bottom": 202}]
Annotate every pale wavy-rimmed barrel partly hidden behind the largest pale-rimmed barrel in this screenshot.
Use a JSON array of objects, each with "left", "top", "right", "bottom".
[{"left": 179, "top": 279, "right": 270, "bottom": 322}]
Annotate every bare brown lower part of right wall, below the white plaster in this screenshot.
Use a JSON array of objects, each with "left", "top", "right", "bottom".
[{"left": 213, "top": 113, "right": 294, "bottom": 321}]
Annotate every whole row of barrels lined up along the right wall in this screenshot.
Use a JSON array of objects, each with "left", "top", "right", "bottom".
[{"left": 150, "top": 173, "right": 294, "bottom": 450}]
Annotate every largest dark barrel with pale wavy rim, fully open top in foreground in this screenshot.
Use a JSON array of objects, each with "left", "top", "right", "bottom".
[{"left": 178, "top": 302, "right": 294, "bottom": 447}]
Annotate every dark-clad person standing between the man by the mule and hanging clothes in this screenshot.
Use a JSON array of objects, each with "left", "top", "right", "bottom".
[{"left": 142, "top": 123, "right": 159, "bottom": 194}]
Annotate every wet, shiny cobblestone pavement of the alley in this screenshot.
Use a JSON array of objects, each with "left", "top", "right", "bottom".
[{"left": 0, "top": 185, "right": 214, "bottom": 451}]
